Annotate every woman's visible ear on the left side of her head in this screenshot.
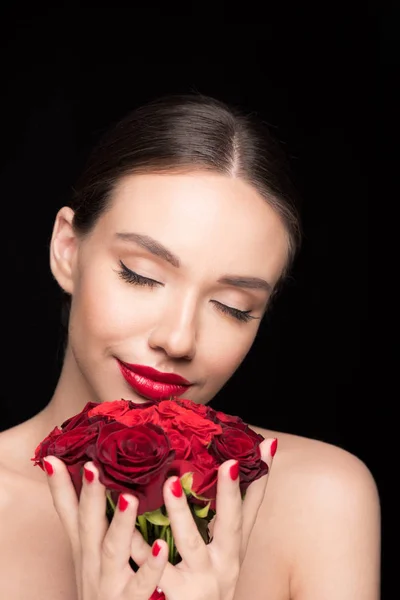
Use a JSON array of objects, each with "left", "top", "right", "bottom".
[{"left": 50, "top": 206, "right": 78, "bottom": 294}]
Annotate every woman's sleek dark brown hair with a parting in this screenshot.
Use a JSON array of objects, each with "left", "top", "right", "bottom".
[{"left": 61, "top": 94, "right": 301, "bottom": 326}]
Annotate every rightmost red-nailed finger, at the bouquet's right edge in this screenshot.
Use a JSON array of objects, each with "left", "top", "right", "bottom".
[{"left": 242, "top": 438, "right": 278, "bottom": 549}]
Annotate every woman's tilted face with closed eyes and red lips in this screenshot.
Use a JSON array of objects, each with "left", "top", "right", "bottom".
[{"left": 52, "top": 171, "right": 288, "bottom": 404}]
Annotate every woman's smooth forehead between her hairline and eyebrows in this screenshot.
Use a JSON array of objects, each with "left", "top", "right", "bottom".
[{"left": 101, "top": 171, "right": 288, "bottom": 278}]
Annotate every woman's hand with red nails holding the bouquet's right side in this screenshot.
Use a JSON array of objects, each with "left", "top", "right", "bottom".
[{"left": 131, "top": 439, "right": 276, "bottom": 600}]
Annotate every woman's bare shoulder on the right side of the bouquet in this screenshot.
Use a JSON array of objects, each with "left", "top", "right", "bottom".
[{"left": 247, "top": 426, "right": 380, "bottom": 600}]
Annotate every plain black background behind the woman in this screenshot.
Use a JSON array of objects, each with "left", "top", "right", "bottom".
[{"left": 0, "top": 4, "right": 392, "bottom": 596}]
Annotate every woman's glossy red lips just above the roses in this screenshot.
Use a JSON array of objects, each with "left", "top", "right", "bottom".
[{"left": 117, "top": 359, "right": 191, "bottom": 400}]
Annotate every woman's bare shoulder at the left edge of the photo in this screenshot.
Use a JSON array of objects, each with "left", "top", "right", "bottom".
[{"left": 0, "top": 429, "right": 76, "bottom": 600}]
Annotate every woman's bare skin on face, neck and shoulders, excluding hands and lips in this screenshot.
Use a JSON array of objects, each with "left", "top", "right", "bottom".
[{"left": 0, "top": 172, "right": 380, "bottom": 600}]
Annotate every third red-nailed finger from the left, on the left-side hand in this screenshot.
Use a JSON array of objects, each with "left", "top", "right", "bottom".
[{"left": 101, "top": 494, "right": 138, "bottom": 580}]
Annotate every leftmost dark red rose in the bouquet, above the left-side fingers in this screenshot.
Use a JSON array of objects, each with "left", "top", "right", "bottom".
[{"left": 32, "top": 421, "right": 104, "bottom": 496}]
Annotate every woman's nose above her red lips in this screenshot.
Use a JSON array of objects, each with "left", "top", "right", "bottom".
[{"left": 149, "top": 301, "right": 197, "bottom": 360}]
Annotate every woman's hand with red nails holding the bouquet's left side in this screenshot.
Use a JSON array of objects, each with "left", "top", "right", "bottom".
[{"left": 45, "top": 456, "right": 168, "bottom": 600}]
